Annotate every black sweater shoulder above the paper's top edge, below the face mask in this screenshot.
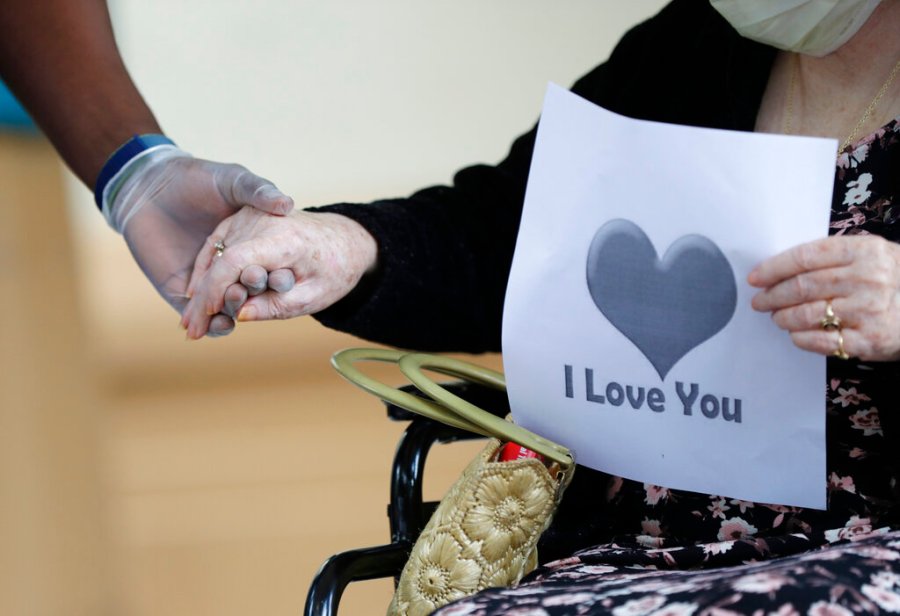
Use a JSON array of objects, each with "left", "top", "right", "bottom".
[{"left": 573, "top": 0, "right": 775, "bottom": 129}]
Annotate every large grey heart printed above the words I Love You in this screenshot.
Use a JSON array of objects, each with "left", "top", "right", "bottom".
[{"left": 587, "top": 219, "right": 737, "bottom": 380}]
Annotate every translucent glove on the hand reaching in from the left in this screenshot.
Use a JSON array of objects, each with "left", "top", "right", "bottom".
[{"left": 103, "top": 146, "right": 294, "bottom": 336}]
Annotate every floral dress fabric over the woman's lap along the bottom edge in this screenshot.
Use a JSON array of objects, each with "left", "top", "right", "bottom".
[{"left": 437, "top": 531, "right": 900, "bottom": 616}]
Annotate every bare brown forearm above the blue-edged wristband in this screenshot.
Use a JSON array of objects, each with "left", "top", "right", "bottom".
[{"left": 0, "top": 0, "right": 160, "bottom": 186}]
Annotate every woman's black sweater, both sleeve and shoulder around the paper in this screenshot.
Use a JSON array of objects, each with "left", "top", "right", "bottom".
[{"left": 308, "top": 0, "right": 776, "bottom": 352}]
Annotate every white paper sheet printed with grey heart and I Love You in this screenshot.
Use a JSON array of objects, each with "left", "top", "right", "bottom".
[{"left": 503, "top": 85, "right": 836, "bottom": 509}]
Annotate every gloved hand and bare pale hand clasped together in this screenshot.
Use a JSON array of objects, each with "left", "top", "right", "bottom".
[{"left": 103, "top": 146, "right": 376, "bottom": 339}]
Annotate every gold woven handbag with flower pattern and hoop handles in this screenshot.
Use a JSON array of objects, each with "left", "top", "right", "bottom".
[{"left": 332, "top": 349, "right": 575, "bottom": 616}]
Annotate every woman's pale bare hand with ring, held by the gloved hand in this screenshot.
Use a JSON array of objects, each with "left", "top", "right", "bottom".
[{"left": 182, "top": 208, "right": 378, "bottom": 339}]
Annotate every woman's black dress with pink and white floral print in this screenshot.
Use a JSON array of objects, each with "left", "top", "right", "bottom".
[{"left": 436, "top": 118, "right": 900, "bottom": 616}]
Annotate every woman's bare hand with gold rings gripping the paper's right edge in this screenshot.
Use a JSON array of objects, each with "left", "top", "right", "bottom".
[{"left": 747, "top": 235, "right": 900, "bottom": 361}]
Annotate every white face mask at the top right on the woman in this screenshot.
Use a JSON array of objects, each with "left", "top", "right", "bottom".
[{"left": 709, "top": 0, "right": 881, "bottom": 56}]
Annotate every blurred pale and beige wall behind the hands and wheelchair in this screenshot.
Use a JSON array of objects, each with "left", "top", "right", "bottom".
[{"left": 0, "top": 0, "right": 663, "bottom": 615}]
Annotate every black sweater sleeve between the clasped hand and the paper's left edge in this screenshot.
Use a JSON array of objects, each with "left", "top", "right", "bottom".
[{"left": 315, "top": 149, "right": 534, "bottom": 352}]
